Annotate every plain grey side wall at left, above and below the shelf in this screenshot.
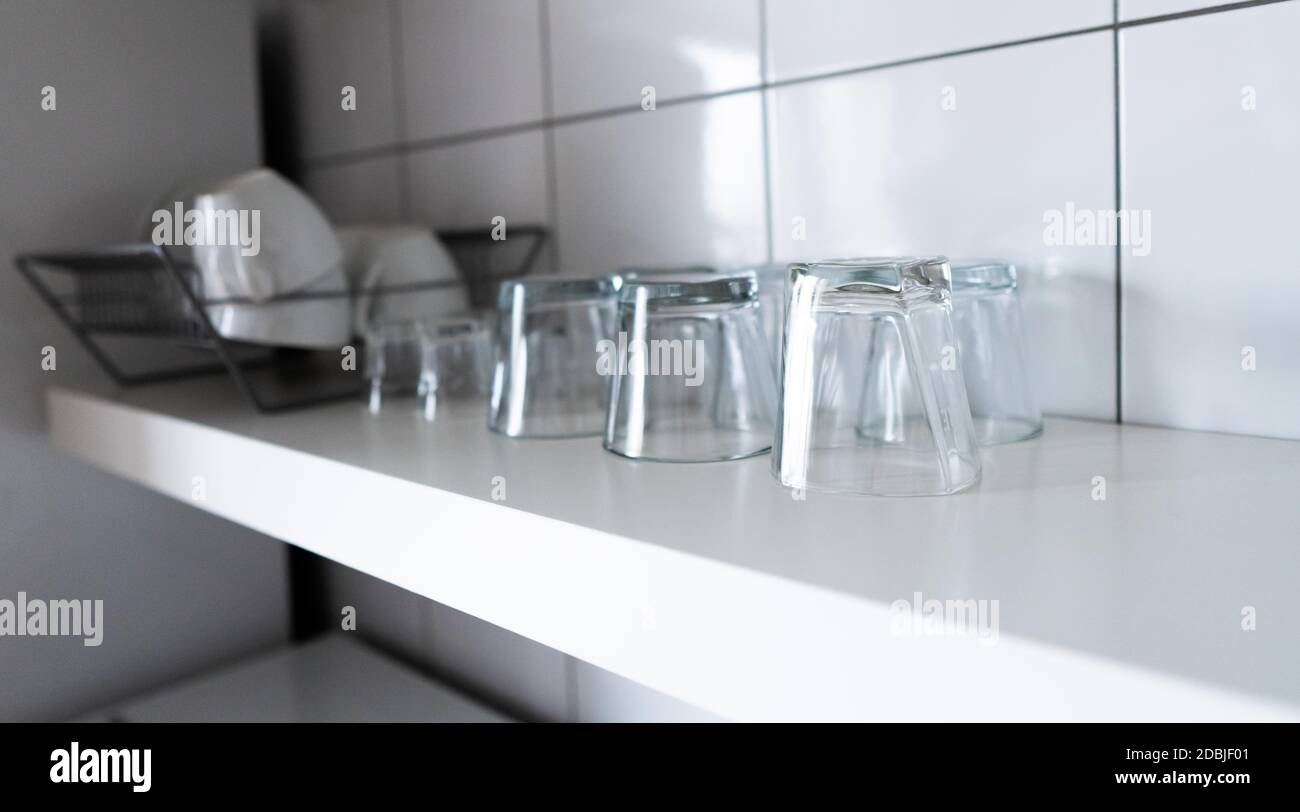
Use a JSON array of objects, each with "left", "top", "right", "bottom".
[{"left": 0, "top": 0, "right": 287, "bottom": 721}]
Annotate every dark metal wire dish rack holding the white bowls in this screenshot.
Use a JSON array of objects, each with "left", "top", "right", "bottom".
[{"left": 14, "top": 226, "right": 547, "bottom": 413}]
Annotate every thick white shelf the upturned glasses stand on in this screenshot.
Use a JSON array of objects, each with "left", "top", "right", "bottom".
[{"left": 48, "top": 381, "right": 1300, "bottom": 720}]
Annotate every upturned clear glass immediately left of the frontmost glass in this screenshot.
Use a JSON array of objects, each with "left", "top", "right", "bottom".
[{"left": 605, "top": 272, "right": 776, "bottom": 463}]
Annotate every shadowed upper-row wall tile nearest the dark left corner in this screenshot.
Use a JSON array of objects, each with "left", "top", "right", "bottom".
[{"left": 287, "top": 0, "right": 399, "bottom": 159}]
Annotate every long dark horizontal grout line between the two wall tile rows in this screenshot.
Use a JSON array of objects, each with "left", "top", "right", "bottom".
[{"left": 299, "top": 0, "right": 1297, "bottom": 170}]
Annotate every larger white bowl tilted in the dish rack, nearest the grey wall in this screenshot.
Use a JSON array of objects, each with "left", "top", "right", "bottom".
[{"left": 148, "top": 169, "right": 351, "bottom": 349}]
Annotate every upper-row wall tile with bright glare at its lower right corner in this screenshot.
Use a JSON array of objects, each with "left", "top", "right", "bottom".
[{"left": 547, "top": 0, "right": 759, "bottom": 116}]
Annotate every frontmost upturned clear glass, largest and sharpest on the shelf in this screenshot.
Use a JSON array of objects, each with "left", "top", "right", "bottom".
[{"left": 772, "top": 257, "right": 980, "bottom": 496}]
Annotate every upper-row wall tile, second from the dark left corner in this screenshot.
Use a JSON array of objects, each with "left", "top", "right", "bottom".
[{"left": 399, "top": 0, "right": 542, "bottom": 140}]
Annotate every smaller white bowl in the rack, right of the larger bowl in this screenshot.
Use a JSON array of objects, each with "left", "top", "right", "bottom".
[{"left": 338, "top": 225, "right": 469, "bottom": 335}]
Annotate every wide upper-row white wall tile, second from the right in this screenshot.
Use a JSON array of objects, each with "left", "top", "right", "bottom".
[{"left": 766, "top": 0, "right": 1112, "bottom": 79}]
